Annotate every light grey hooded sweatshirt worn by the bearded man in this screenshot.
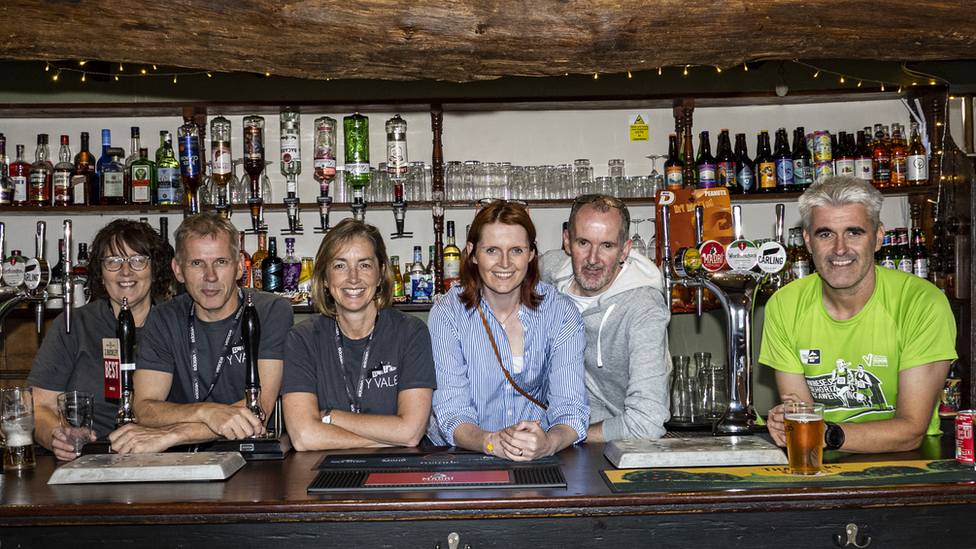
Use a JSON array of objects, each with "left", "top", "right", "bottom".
[{"left": 540, "top": 250, "right": 671, "bottom": 440}]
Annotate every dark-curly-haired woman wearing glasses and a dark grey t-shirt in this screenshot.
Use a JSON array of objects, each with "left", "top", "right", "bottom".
[{"left": 27, "top": 219, "right": 173, "bottom": 460}]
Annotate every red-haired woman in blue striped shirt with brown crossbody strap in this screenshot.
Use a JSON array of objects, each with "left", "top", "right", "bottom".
[{"left": 427, "top": 200, "right": 590, "bottom": 461}]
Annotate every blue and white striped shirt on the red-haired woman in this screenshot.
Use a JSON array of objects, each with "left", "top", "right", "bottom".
[{"left": 427, "top": 282, "right": 590, "bottom": 445}]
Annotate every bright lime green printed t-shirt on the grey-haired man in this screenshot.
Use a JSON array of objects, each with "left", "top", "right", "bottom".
[{"left": 759, "top": 266, "right": 958, "bottom": 434}]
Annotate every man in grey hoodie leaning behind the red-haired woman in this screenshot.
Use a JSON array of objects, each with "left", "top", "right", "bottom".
[{"left": 539, "top": 195, "right": 671, "bottom": 442}]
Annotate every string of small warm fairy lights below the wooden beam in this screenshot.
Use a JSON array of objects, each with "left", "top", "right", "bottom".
[{"left": 44, "top": 59, "right": 949, "bottom": 93}]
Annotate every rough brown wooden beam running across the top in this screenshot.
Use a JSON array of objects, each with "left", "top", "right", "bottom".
[{"left": 0, "top": 0, "right": 976, "bottom": 82}]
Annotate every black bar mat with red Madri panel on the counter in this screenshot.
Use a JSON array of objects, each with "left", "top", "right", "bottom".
[{"left": 308, "top": 451, "right": 566, "bottom": 494}]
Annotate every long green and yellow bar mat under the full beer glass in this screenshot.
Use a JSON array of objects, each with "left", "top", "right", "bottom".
[{"left": 600, "top": 460, "right": 976, "bottom": 493}]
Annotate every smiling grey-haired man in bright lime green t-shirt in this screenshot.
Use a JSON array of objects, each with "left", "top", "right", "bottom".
[{"left": 759, "top": 176, "right": 957, "bottom": 452}]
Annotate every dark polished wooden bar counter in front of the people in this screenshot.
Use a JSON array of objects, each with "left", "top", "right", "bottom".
[{"left": 0, "top": 434, "right": 976, "bottom": 549}]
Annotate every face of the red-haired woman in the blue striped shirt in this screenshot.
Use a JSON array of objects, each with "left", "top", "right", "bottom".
[{"left": 468, "top": 223, "right": 535, "bottom": 299}]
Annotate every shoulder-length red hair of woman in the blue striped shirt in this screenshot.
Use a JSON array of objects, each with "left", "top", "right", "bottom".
[{"left": 460, "top": 200, "right": 543, "bottom": 309}]
